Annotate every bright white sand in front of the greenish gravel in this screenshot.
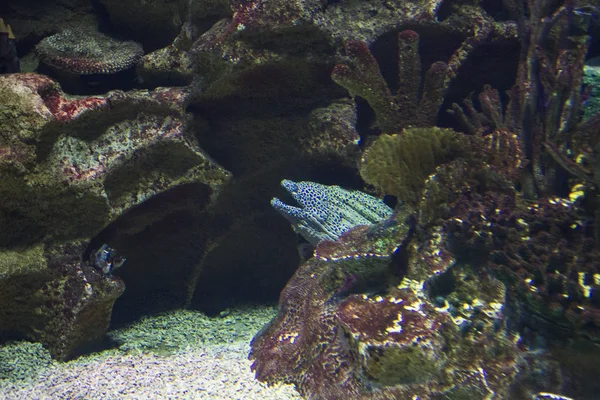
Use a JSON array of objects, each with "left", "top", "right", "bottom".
[{"left": 0, "top": 343, "right": 301, "bottom": 400}]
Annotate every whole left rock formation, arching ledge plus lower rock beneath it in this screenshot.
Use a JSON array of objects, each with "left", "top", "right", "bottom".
[{"left": 0, "top": 74, "right": 229, "bottom": 359}]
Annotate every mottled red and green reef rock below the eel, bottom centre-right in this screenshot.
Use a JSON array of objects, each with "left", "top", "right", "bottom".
[{"left": 251, "top": 208, "right": 554, "bottom": 399}]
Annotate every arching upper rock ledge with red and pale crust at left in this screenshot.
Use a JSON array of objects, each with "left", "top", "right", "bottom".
[{"left": 0, "top": 74, "right": 229, "bottom": 246}]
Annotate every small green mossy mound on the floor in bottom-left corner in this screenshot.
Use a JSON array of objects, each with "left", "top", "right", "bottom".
[{"left": 0, "top": 341, "right": 52, "bottom": 382}]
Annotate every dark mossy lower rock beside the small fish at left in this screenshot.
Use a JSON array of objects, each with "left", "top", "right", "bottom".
[{"left": 0, "top": 241, "right": 125, "bottom": 359}]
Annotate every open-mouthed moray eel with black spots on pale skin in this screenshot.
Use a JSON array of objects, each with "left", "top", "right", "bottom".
[{"left": 271, "top": 179, "right": 393, "bottom": 244}]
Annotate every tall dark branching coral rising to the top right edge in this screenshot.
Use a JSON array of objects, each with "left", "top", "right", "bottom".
[{"left": 454, "top": 0, "right": 600, "bottom": 197}]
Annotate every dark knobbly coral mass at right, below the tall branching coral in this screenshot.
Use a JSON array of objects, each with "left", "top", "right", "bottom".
[{"left": 420, "top": 156, "right": 600, "bottom": 338}]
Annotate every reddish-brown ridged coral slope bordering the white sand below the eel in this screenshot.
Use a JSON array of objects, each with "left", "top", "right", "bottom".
[{"left": 251, "top": 219, "right": 408, "bottom": 398}]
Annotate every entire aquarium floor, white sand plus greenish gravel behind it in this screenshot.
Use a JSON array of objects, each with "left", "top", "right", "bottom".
[{"left": 0, "top": 307, "right": 302, "bottom": 400}]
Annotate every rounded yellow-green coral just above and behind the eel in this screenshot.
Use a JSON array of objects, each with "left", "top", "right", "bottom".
[{"left": 360, "top": 127, "right": 467, "bottom": 204}]
